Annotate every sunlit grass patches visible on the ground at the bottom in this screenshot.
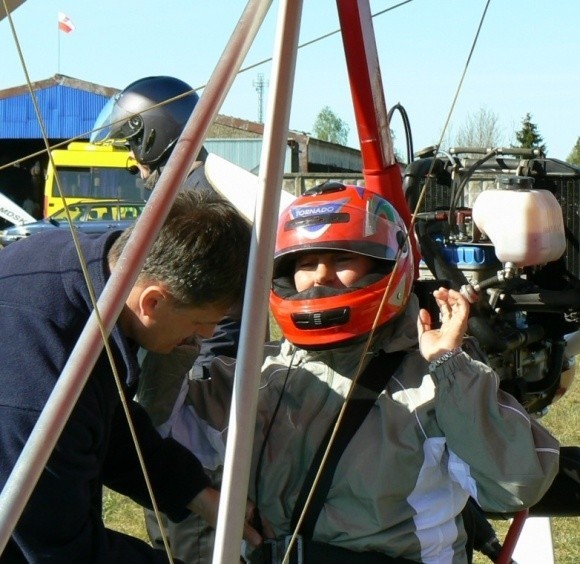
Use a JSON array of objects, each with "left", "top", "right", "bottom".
[{"left": 103, "top": 357, "right": 580, "bottom": 564}]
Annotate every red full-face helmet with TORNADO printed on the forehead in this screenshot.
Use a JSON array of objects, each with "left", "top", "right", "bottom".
[{"left": 270, "top": 182, "right": 414, "bottom": 349}]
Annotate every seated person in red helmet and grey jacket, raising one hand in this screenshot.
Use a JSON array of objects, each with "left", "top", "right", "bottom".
[{"left": 138, "top": 183, "right": 559, "bottom": 564}]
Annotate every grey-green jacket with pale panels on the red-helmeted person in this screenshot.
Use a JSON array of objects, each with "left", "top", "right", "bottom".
[{"left": 138, "top": 299, "right": 559, "bottom": 563}]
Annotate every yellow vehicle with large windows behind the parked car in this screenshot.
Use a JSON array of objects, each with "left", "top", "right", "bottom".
[{"left": 43, "top": 141, "right": 149, "bottom": 217}]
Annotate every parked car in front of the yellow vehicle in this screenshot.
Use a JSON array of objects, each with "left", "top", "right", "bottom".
[{"left": 0, "top": 200, "right": 145, "bottom": 246}]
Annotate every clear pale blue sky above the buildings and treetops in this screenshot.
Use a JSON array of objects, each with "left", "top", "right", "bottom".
[{"left": 0, "top": 0, "right": 580, "bottom": 160}]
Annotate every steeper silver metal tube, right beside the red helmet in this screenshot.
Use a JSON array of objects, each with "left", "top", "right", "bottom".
[{"left": 213, "top": 0, "right": 302, "bottom": 564}]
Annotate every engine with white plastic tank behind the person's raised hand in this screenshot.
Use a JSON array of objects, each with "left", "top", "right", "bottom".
[{"left": 403, "top": 148, "right": 580, "bottom": 416}]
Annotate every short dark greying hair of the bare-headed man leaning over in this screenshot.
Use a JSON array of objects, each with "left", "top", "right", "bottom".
[{"left": 109, "top": 190, "right": 251, "bottom": 306}]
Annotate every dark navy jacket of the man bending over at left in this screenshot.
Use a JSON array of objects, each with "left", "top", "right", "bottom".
[{"left": 0, "top": 230, "right": 209, "bottom": 564}]
